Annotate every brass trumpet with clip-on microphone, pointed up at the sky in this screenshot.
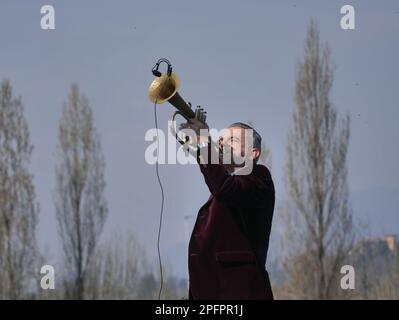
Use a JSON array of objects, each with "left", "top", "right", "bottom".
[{"left": 148, "top": 58, "right": 206, "bottom": 145}]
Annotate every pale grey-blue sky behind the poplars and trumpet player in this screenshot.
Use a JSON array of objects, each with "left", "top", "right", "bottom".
[{"left": 0, "top": 0, "right": 399, "bottom": 274}]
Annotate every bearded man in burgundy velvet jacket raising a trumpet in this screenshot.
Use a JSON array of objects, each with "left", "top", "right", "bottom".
[{"left": 180, "top": 118, "right": 275, "bottom": 300}]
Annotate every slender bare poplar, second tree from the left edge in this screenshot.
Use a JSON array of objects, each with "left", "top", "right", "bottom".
[{"left": 56, "top": 85, "right": 108, "bottom": 299}]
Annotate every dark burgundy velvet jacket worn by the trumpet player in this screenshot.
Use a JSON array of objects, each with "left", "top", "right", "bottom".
[{"left": 188, "top": 159, "right": 275, "bottom": 300}]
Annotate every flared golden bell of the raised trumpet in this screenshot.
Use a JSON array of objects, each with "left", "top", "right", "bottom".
[{"left": 148, "top": 73, "right": 180, "bottom": 104}]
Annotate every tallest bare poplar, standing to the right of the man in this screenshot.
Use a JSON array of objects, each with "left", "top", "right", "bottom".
[{"left": 285, "top": 21, "right": 354, "bottom": 299}]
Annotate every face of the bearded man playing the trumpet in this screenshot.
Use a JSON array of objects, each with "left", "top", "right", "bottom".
[{"left": 219, "top": 127, "right": 259, "bottom": 167}]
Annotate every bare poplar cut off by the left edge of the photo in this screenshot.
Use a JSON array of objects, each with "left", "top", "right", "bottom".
[{"left": 0, "top": 80, "right": 38, "bottom": 299}]
